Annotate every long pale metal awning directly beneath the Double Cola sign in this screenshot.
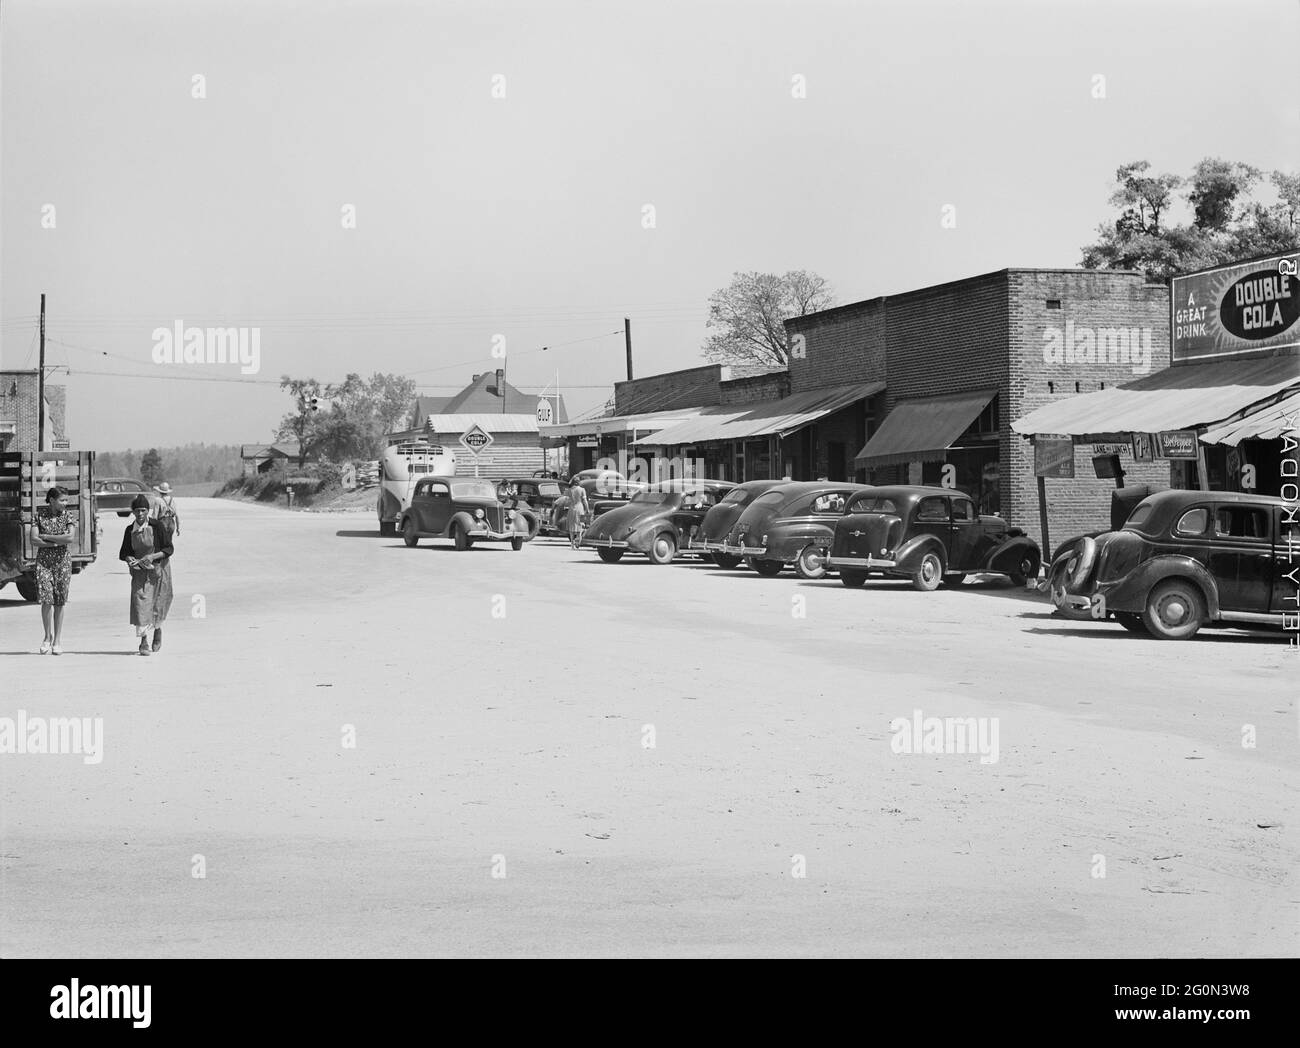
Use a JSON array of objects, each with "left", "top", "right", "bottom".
[{"left": 1011, "top": 356, "right": 1300, "bottom": 442}]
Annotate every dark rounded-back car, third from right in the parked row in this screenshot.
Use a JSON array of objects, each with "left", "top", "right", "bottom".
[{"left": 722, "top": 480, "right": 866, "bottom": 579}]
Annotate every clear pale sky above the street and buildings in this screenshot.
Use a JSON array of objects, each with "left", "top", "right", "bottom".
[{"left": 0, "top": 0, "right": 1300, "bottom": 450}]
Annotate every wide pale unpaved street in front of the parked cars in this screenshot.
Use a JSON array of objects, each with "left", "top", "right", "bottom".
[{"left": 0, "top": 499, "right": 1300, "bottom": 957}]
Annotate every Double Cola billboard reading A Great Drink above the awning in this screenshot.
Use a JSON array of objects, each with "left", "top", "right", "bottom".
[{"left": 1170, "top": 252, "right": 1300, "bottom": 364}]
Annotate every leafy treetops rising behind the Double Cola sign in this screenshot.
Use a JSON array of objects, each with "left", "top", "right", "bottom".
[{"left": 1083, "top": 157, "right": 1300, "bottom": 281}]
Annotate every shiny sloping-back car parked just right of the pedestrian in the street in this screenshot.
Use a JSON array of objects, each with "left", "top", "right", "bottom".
[{"left": 580, "top": 478, "right": 736, "bottom": 564}]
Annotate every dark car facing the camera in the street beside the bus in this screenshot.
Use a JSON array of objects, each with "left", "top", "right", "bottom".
[{"left": 399, "top": 477, "right": 532, "bottom": 550}]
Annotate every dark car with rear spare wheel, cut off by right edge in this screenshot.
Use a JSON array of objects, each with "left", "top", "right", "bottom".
[{"left": 1049, "top": 490, "right": 1300, "bottom": 640}]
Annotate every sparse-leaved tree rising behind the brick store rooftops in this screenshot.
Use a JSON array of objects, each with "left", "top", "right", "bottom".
[{"left": 703, "top": 269, "right": 835, "bottom": 367}]
